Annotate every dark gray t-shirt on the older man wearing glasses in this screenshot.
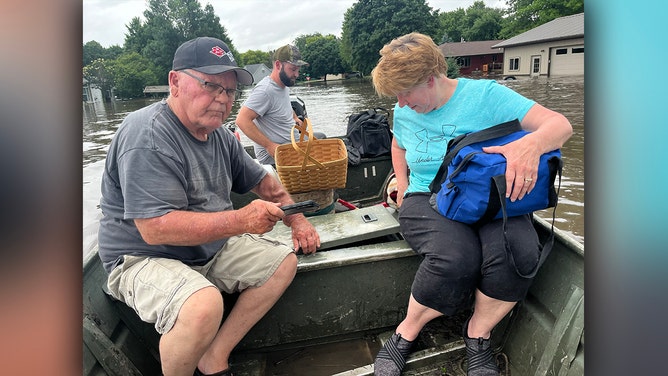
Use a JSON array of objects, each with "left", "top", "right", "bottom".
[{"left": 98, "top": 100, "right": 266, "bottom": 272}]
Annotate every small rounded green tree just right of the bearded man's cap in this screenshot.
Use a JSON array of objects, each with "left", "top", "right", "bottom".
[{"left": 295, "top": 33, "right": 344, "bottom": 80}]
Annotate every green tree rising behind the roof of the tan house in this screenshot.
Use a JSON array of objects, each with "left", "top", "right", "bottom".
[{"left": 499, "top": 0, "right": 584, "bottom": 39}]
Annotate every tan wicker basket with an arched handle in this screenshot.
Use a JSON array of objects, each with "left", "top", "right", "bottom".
[{"left": 274, "top": 118, "right": 348, "bottom": 193}]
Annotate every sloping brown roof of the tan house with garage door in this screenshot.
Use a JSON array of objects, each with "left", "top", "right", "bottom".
[{"left": 492, "top": 13, "right": 584, "bottom": 48}]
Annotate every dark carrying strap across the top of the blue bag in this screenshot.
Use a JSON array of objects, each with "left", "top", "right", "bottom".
[{"left": 429, "top": 119, "right": 522, "bottom": 194}]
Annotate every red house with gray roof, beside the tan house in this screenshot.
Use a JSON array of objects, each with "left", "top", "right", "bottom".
[{"left": 438, "top": 40, "right": 503, "bottom": 76}]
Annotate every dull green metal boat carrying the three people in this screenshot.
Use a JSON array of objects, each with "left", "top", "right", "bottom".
[{"left": 83, "top": 151, "right": 584, "bottom": 376}]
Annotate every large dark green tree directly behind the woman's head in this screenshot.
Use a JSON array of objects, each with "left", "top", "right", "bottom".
[{"left": 340, "top": 0, "right": 442, "bottom": 75}]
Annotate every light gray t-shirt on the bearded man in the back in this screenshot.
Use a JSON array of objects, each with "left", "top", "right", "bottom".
[{"left": 243, "top": 76, "right": 295, "bottom": 164}]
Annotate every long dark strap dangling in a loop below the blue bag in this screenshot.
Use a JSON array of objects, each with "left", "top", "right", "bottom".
[{"left": 486, "top": 164, "right": 562, "bottom": 278}]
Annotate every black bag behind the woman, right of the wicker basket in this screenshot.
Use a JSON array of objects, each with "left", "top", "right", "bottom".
[{"left": 346, "top": 108, "right": 392, "bottom": 158}]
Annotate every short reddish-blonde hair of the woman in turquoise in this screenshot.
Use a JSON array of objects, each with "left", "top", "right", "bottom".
[{"left": 371, "top": 33, "right": 448, "bottom": 97}]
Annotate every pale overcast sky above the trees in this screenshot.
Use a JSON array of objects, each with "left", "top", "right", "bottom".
[{"left": 83, "top": 0, "right": 506, "bottom": 52}]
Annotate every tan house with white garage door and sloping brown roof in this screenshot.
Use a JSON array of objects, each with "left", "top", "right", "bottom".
[{"left": 492, "top": 13, "right": 584, "bottom": 78}]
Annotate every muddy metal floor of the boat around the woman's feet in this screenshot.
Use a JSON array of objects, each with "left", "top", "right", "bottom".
[{"left": 227, "top": 312, "right": 510, "bottom": 376}]
